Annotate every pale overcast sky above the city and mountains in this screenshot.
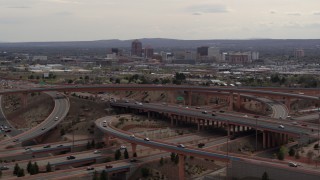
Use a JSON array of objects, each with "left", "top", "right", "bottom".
[{"left": 0, "top": 0, "right": 320, "bottom": 42}]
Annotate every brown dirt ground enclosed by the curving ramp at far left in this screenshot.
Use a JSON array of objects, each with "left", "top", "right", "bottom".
[{"left": 2, "top": 93, "right": 54, "bottom": 129}]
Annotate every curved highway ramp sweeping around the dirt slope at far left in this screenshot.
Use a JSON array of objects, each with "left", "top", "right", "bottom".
[{"left": 0, "top": 92, "right": 70, "bottom": 147}]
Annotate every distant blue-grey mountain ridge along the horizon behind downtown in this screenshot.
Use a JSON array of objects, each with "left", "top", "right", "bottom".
[{"left": 0, "top": 38, "right": 320, "bottom": 49}]
